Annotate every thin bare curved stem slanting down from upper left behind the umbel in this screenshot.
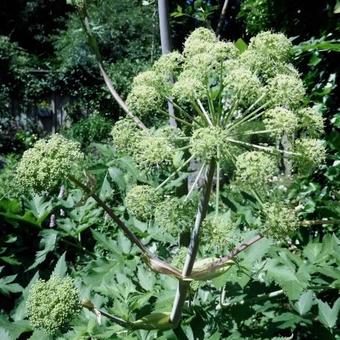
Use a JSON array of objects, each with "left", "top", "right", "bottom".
[{"left": 79, "top": 7, "right": 147, "bottom": 130}]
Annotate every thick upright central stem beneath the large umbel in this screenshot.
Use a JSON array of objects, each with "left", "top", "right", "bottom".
[{"left": 170, "top": 160, "right": 215, "bottom": 327}]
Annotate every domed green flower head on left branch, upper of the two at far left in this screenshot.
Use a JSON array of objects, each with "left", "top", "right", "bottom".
[{"left": 17, "top": 134, "right": 83, "bottom": 192}]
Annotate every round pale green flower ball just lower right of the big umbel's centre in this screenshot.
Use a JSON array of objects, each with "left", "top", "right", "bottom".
[{"left": 235, "top": 151, "right": 278, "bottom": 190}]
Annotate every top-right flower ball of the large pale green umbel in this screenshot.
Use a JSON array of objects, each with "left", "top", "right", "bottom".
[{"left": 249, "top": 32, "right": 293, "bottom": 62}]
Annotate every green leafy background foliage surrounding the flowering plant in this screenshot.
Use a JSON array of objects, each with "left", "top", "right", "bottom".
[{"left": 0, "top": 0, "right": 340, "bottom": 339}]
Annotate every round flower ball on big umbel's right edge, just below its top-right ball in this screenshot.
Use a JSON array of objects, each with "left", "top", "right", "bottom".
[{"left": 268, "top": 74, "right": 306, "bottom": 108}]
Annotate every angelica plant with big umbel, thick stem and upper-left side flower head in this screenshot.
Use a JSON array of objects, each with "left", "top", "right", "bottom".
[{"left": 18, "top": 28, "right": 326, "bottom": 329}]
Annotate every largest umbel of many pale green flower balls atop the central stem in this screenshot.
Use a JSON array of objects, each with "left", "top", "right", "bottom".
[{"left": 112, "top": 28, "right": 326, "bottom": 239}]
